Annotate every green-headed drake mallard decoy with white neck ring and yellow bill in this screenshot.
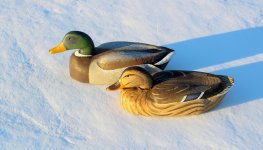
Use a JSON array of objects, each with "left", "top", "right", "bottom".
[{"left": 49, "top": 31, "right": 173, "bottom": 84}]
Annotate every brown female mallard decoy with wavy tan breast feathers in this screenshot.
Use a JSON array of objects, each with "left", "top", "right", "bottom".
[{"left": 107, "top": 66, "right": 234, "bottom": 116}]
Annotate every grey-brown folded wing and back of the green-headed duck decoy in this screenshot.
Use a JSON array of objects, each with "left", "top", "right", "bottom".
[{"left": 95, "top": 42, "right": 173, "bottom": 70}]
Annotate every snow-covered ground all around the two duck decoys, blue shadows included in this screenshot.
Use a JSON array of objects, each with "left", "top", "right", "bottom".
[{"left": 0, "top": 0, "right": 263, "bottom": 150}]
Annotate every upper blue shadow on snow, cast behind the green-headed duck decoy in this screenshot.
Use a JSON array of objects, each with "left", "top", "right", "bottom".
[{"left": 165, "top": 27, "right": 263, "bottom": 70}]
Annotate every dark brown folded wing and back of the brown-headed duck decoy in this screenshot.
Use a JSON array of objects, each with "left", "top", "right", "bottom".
[{"left": 150, "top": 71, "right": 221, "bottom": 104}]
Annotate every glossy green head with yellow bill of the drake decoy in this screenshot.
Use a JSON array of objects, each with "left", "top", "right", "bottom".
[{"left": 49, "top": 31, "right": 94, "bottom": 55}]
